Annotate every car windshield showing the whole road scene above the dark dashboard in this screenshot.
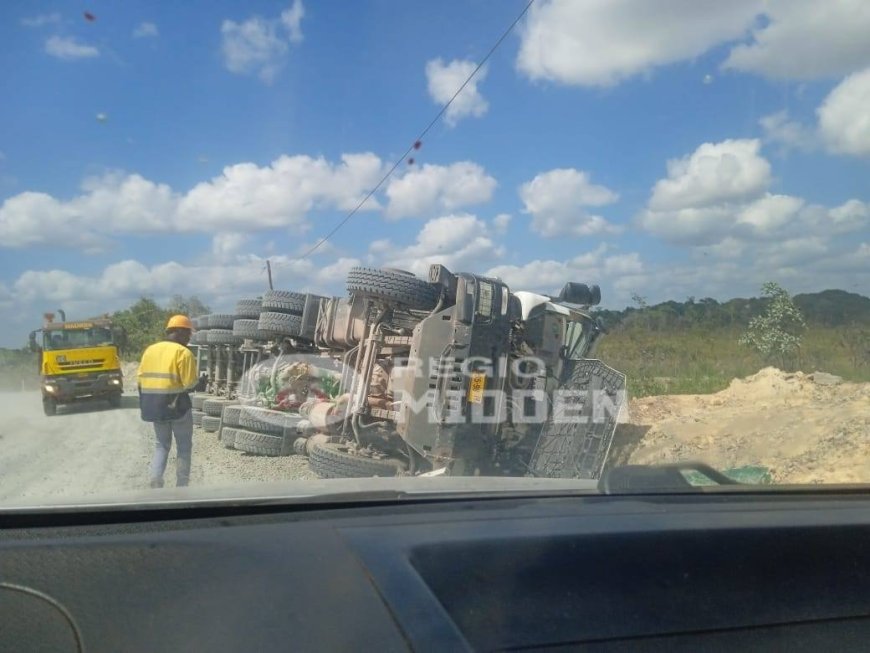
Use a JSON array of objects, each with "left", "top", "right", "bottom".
[{"left": 0, "top": 0, "right": 870, "bottom": 508}]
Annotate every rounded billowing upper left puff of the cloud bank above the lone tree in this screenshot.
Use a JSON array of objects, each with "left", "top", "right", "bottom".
[{"left": 649, "top": 139, "right": 770, "bottom": 211}]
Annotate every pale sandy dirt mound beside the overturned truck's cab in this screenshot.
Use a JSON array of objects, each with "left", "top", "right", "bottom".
[{"left": 611, "top": 367, "right": 870, "bottom": 483}]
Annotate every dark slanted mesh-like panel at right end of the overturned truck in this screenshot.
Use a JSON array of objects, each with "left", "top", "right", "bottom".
[{"left": 529, "top": 360, "right": 626, "bottom": 479}]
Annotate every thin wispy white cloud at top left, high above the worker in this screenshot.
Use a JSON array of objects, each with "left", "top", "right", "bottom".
[{"left": 221, "top": 0, "right": 305, "bottom": 84}]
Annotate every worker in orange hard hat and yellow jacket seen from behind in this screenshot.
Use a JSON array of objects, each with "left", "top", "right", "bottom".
[{"left": 138, "top": 315, "right": 199, "bottom": 488}]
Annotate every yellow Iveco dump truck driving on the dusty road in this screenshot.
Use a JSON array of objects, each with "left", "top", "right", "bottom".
[{"left": 30, "top": 313, "right": 126, "bottom": 415}]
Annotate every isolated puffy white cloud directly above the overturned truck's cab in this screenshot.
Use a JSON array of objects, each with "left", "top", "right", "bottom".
[{"left": 519, "top": 168, "right": 620, "bottom": 238}]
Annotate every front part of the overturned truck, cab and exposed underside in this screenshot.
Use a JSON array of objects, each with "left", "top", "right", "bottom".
[{"left": 242, "top": 265, "right": 625, "bottom": 478}]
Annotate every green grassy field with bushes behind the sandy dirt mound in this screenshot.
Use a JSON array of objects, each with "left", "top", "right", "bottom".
[{"left": 596, "top": 284, "right": 870, "bottom": 397}]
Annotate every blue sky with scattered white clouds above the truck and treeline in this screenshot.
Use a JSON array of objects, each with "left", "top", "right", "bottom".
[{"left": 0, "top": 0, "right": 870, "bottom": 346}]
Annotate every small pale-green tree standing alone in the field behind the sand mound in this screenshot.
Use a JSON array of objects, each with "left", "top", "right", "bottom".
[{"left": 739, "top": 281, "right": 807, "bottom": 369}]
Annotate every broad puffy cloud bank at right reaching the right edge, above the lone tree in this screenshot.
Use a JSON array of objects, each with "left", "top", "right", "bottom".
[{"left": 639, "top": 140, "right": 868, "bottom": 246}]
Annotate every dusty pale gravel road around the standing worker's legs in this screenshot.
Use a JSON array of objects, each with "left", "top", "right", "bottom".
[{"left": 0, "top": 392, "right": 315, "bottom": 504}]
